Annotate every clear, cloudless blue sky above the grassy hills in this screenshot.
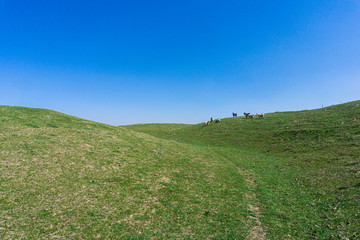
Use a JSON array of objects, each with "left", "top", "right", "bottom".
[{"left": 0, "top": 0, "right": 360, "bottom": 125}]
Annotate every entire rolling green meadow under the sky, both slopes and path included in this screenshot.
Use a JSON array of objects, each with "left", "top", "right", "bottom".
[{"left": 0, "top": 101, "right": 360, "bottom": 239}]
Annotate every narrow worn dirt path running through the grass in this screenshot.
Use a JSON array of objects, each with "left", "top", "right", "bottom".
[{"left": 238, "top": 167, "right": 266, "bottom": 239}]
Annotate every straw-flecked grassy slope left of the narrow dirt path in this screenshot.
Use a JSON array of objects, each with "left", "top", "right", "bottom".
[{"left": 0, "top": 106, "right": 253, "bottom": 239}]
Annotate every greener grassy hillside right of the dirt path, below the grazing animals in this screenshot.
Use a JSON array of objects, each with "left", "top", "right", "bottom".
[{"left": 127, "top": 101, "right": 360, "bottom": 239}]
